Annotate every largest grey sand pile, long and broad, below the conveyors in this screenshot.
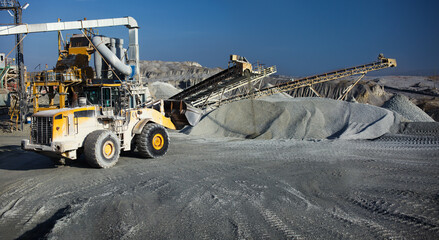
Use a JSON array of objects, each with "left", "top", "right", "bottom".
[{"left": 186, "top": 98, "right": 400, "bottom": 139}]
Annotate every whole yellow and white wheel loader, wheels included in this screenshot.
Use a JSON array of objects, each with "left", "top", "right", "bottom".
[{"left": 21, "top": 91, "right": 181, "bottom": 168}]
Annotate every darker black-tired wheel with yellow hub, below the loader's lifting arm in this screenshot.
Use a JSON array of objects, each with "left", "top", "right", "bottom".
[{"left": 137, "top": 123, "right": 169, "bottom": 158}]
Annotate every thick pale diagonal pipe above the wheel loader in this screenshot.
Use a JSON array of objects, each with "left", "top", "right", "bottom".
[{"left": 92, "top": 36, "right": 136, "bottom": 78}]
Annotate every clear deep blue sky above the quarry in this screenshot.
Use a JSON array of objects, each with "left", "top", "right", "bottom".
[{"left": 0, "top": 0, "right": 439, "bottom": 76}]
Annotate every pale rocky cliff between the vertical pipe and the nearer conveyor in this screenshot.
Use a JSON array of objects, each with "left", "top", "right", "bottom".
[{"left": 140, "top": 61, "right": 222, "bottom": 82}]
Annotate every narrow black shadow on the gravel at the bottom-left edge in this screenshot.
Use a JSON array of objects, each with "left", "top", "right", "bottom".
[{"left": 17, "top": 205, "right": 71, "bottom": 239}]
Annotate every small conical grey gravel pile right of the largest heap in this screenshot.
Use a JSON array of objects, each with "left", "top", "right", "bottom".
[{"left": 382, "top": 94, "right": 434, "bottom": 122}]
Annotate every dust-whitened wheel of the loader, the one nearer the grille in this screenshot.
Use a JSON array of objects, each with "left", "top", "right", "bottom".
[{"left": 84, "top": 130, "right": 120, "bottom": 168}]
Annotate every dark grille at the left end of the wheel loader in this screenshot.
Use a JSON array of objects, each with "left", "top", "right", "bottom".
[{"left": 31, "top": 117, "right": 52, "bottom": 145}]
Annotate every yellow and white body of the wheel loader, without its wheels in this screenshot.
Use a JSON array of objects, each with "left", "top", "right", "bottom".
[{"left": 22, "top": 102, "right": 176, "bottom": 160}]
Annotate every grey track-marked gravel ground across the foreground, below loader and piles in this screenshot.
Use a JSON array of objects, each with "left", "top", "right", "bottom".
[{"left": 0, "top": 133, "right": 439, "bottom": 239}]
